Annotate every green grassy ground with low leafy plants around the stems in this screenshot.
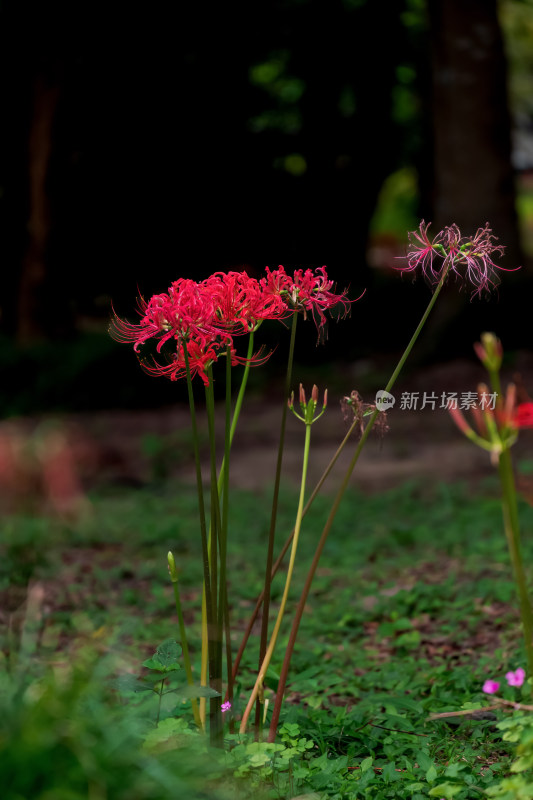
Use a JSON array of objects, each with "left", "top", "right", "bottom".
[{"left": 0, "top": 482, "right": 533, "bottom": 800}]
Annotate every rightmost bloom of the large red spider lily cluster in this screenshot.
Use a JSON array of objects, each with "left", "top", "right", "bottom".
[{"left": 260, "top": 265, "right": 352, "bottom": 339}]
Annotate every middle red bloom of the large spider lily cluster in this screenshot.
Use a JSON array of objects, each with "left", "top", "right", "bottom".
[{"left": 204, "top": 272, "right": 288, "bottom": 333}]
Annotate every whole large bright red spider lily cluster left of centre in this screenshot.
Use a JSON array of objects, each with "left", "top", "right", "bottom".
[{"left": 111, "top": 266, "right": 351, "bottom": 385}]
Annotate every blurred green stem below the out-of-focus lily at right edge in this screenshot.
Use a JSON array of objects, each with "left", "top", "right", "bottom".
[{"left": 498, "top": 447, "right": 533, "bottom": 677}]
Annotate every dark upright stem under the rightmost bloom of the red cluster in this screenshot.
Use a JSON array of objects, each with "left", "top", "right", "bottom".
[{"left": 255, "top": 310, "right": 298, "bottom": 737}]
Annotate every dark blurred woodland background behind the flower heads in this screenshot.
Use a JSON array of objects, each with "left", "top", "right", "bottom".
[{"left": 0, "top": 0, "right": 533, "bottom": 415}]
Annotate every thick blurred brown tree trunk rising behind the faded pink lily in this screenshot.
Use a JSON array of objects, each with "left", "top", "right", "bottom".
[{"left": 428, "top": 0, "right": 521, "bottom": 267}]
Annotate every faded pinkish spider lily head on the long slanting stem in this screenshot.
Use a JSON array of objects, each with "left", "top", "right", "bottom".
[{"left": 400, "top": 220, "right": 519, "bottom": 295}]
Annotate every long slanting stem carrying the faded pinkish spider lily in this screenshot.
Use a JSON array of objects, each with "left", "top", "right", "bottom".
[{"left": 268, "top": 278, "right": 448, "bottom": 742}]
